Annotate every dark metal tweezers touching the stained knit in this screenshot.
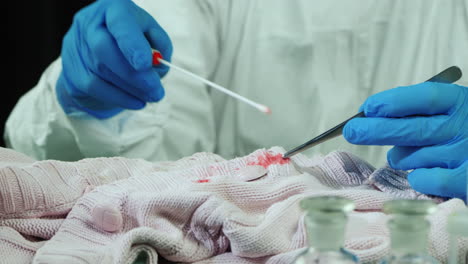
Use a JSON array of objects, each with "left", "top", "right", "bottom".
[{"left": 283, "top": 66, "right": 462, "bottom": 158}]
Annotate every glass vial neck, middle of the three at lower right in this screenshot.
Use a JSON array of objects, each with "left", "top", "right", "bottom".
[{"left": 381, "top": 199, "right": 439, "bottom": 264}]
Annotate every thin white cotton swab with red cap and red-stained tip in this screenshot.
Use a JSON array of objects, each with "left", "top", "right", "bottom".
[{"left": 152, "top": 49, "right": 271, "bottom": 114}]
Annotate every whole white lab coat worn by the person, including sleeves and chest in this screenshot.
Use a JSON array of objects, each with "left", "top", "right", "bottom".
[{"left": 5, "top": 0, "right": 468, "bottom": 166}]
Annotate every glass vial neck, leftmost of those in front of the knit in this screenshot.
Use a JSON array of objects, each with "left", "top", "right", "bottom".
[{"left": 294, "top": 196, "right": 358, "bottom": 264}]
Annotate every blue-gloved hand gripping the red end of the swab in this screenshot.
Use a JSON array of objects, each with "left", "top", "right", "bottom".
[{"left": 56, "top": 0, "right": 172, "bottom": 118}]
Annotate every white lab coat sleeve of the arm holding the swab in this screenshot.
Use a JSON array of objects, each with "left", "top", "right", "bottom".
[{"left": 5, "top": 0, "right": 219, "bottom": 161}]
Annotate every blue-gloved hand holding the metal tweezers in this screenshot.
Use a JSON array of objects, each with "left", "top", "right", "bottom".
[{"left": 343, "top": 82, "right": 468, "bottom": 199}]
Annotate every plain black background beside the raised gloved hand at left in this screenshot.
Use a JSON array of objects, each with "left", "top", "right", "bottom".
[{"left": 4, "top": 0, "right": 94, "bottom": 147}]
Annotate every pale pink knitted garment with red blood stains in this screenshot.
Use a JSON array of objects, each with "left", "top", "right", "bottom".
[{"left": 0, "top": 147, "right": 468, "bottom": 263}]
